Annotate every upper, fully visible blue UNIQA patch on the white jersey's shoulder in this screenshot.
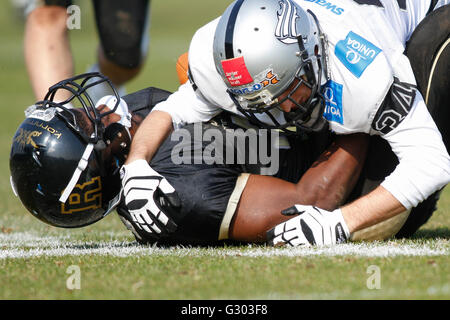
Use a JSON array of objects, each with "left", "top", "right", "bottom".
[{"left": 334, "top": 31, "right": 382, "bottom": 78}]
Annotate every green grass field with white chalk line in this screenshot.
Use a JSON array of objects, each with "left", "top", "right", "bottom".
[{"left": 0, "top": 0, "right": 450, "bottom": 300}]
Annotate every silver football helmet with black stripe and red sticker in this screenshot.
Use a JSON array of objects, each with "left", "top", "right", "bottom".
[{"left": 213, "top": 0, "right": 327, "bottom": 131}]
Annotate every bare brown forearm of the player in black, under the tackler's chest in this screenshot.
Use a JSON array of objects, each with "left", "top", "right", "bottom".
[{"left": 297, "top": 134, "right": 368, "bottom": 210}]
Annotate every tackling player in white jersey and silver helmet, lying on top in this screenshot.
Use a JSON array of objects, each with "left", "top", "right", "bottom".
[{"left": 120, "top": 0, "right": 450, "bottom": 245}]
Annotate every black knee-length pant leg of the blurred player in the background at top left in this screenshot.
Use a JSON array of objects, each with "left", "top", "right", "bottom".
[{"left": 93, "top": 0, "right": 149, "bottom": 69}]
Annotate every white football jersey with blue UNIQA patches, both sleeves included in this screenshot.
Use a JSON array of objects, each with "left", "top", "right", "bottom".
[{"left": 154, "top": 0, "right": 450, "bottom": 208}]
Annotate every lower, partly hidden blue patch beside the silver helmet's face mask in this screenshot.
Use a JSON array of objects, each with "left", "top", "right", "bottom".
[{"left": 323, "top": 80, "right": 344, "bottom": 124}]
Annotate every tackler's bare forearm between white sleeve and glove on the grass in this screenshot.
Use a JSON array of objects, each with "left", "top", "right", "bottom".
[{"left": 341, "top": 186, "right": 406, "bottom": 233}]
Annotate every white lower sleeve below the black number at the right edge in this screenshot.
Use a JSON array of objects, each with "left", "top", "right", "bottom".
[{"left": 381, "top": 93, "right": 450, "bottom": 209}]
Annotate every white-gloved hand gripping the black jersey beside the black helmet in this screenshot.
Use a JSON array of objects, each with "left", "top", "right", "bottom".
[{"left": 120, "top": 160, "right": 181, "bottom": 236}]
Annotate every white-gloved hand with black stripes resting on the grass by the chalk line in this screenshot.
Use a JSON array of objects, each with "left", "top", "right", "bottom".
[{"left": 267, "top": 205, "right": 350, "bottom": 247}]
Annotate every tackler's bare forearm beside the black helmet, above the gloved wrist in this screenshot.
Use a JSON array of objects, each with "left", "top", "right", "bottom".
[{"left": 125, "top": 111, "right": 173, "bottom": 164}]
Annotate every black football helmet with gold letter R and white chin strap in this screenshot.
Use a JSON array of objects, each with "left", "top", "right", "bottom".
[{"left": 10, "top": 73, "right": 131, "bottom": 228}]
